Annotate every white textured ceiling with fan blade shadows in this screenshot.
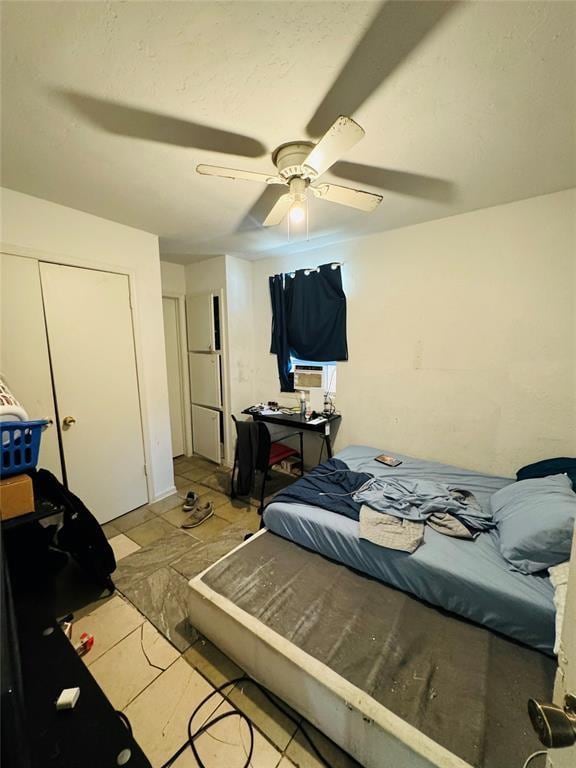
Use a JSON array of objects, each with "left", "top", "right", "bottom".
[{"left": 2, "top": 0, "right": 576, "bottom": 263}]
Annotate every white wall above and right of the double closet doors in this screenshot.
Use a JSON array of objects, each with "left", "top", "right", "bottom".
[{"left": 1, "top": 189, "right": 174, "bottom": 500}]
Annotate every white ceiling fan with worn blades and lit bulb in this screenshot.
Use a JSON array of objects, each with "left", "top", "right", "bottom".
[{"left": 196, "top": 116, "right": 382, "bottom": 227}]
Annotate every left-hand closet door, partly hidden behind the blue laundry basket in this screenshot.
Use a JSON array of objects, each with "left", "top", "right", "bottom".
[{"left": 0, "top": 253, "right": 62, "bottom": 480}]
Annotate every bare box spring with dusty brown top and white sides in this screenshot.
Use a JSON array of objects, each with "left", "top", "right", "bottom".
[{"left": 189, "top": 530, "right": 555, "bottom": 768}]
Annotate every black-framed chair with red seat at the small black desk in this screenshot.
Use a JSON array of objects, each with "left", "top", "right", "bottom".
[{"left": 230, "top": 416, "right": 304, "bottom": 515}]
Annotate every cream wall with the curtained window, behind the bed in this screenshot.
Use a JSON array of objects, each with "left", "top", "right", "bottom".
[{"left": 246, "top": 190, "right": 576, "bottom": 475}]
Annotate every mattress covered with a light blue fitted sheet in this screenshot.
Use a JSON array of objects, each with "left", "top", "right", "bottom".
[{"left": 264, "top": 446, "right": 555, "bottom": 654}]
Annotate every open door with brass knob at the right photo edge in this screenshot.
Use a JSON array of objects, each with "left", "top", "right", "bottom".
[{"left": 548, "top": 535, "right": 576, "bottom": 768}]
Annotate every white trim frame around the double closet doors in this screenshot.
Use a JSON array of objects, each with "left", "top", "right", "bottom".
[{"left": 0, "top": 242, "right": 160, "bottom": 503}]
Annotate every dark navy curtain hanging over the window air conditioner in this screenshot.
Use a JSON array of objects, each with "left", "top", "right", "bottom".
[{"left": 269, "top": 264, "right": 348, "bottom": 392}]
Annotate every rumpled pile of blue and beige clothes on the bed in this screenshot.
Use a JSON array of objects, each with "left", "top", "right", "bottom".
[{"left": 274, "top": 459, "right": 494, "bottom": 552}]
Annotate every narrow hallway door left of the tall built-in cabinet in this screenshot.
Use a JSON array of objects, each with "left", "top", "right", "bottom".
[{"left": 162, "top": 296, "right": 184, "bottom": 457}]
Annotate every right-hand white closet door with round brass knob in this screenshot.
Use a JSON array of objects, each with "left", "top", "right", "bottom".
[{"left": 40, "top": 263, "right": 148, "bottom": 523}]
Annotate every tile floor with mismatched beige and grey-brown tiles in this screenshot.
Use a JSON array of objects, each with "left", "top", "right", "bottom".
[{"left": 73, "top": 457, "right": 358, "bottom": 768}]
